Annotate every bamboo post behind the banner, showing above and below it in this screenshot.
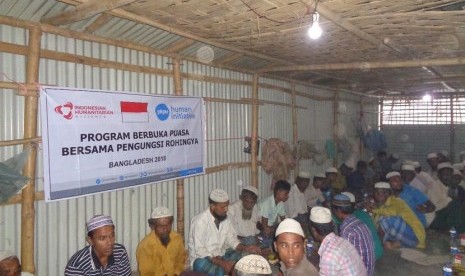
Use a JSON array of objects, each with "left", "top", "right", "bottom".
[{"left": 173, "top": 57, "right": 184, "bottom": 237}]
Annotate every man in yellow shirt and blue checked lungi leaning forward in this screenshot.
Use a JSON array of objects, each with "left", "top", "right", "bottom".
[{"left": 366, "top": 182, "right": 426, "bottom": 249}]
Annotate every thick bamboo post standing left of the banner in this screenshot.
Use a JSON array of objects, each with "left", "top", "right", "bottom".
[{"left": 21, "top": 27, "right": 42, "bottom": 274}]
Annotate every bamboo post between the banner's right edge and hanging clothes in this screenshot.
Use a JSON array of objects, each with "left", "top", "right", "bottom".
[{"left": 250, "top": 74, "right": 259, "bottom": 188}]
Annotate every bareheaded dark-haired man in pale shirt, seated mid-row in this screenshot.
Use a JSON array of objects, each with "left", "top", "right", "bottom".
[{"left": 259, "top": 180, "right": 291, "bottom": 247}]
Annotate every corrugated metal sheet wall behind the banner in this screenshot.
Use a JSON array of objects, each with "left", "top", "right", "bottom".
[{"left": 0, "top": 26, "right": 358, "bottom": 276}]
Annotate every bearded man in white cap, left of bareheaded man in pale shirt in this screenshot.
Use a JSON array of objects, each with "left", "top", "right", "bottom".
[{"left": 228, "top": 186, "right": 260, "bottom": 245}]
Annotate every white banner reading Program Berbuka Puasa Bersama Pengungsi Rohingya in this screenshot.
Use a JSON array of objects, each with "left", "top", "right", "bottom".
[{"left": 40, "top": 87, "right": 205, "bottom": 201}]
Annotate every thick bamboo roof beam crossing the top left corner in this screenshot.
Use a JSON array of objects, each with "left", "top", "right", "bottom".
[{"left": 40, "top": 0, "right": 137, "bottom": 26}]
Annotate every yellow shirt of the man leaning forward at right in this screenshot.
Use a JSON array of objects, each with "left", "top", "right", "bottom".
[{"left": 373, "top": 196, "right": 426, "bottom": 248}]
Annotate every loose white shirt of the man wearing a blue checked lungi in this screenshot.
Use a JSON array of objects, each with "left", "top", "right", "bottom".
[{"left": 188, "top": 208, "right": 240, "bottom": 265}]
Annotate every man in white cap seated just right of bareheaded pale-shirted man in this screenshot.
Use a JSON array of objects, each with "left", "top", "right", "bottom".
[{"left": 284, "top": 171, "right": 310, "bottom": 235}]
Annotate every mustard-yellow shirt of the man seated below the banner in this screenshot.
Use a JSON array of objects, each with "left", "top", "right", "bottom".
[{"left": 136, "top": 231, "right": 187, "bottom": 276}]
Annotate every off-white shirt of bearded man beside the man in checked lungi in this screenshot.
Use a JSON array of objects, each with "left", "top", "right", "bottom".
[{"left": 228, "top": 200, "right": 260, "bottom": 237}]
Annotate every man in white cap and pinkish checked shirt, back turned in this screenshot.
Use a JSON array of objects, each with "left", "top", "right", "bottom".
[{"left": 310, "top": 206, "right": 367, "bottom": 276}]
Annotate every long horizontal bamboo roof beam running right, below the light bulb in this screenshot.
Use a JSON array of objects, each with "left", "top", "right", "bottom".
[{"left": 261, "top": 57, "right": 465, "bottom": 72}]
